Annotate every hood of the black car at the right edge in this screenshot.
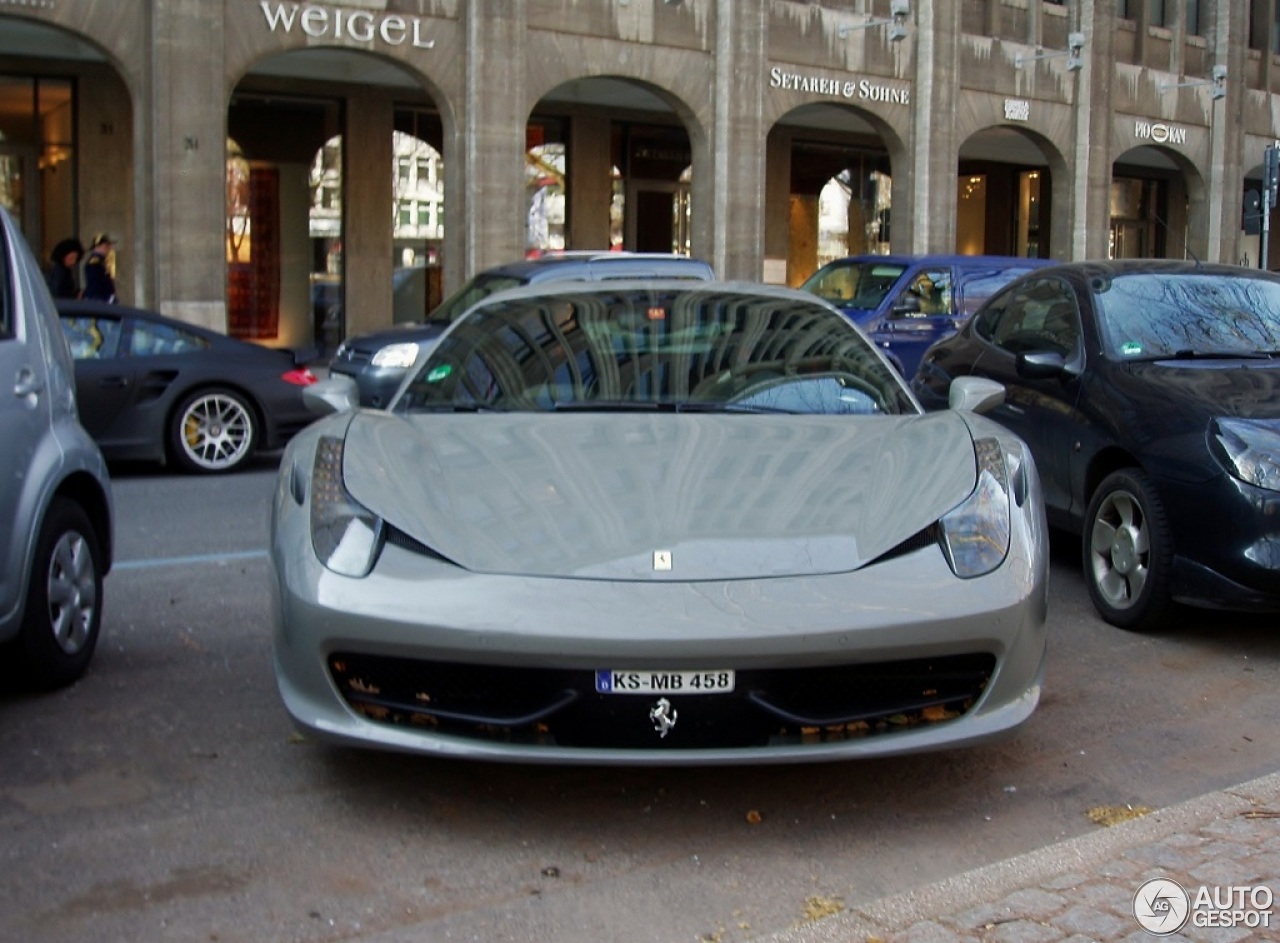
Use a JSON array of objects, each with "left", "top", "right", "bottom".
[{"left": 1129, "top": 360, "right": 1280, "bottom": 429}]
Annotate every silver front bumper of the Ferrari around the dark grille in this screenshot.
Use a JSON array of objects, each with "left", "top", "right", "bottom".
[{"left": 271, "top": 458, "right": 1047, "bottom": 765}]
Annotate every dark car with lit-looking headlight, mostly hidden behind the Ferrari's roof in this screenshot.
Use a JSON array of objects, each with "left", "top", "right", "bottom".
[{"left": 329, "top": 252, "right": 714, "bottom": 407}]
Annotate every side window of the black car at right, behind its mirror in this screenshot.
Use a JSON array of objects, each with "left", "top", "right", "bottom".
[{"left": 974, "top": 279, "right": 1080, "bottom": 357}]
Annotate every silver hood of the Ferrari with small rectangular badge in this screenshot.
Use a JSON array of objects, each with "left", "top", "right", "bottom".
[{"left": 344, "top": 411, "right": 975, "bottom": 581}]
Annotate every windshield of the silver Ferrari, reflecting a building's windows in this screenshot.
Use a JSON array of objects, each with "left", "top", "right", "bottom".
[{"left": 392, "top": 285, "right": 919, "bottom": 415}]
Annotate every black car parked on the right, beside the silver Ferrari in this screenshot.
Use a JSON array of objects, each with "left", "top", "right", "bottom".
[{"left": 913, "top": 261, "right": 1280, "bottom": 628}]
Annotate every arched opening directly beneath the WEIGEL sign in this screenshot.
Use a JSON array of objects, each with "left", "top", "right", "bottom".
[{"left": 227, "top": 49, "right": 445, "bottom": 354}]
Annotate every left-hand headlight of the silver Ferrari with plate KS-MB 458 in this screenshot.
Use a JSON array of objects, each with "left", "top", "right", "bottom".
[{"left": 311, "top": 435, "right": 383, "bottom": 577}]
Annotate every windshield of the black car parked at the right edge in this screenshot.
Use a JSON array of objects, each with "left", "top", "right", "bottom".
[{"left": 1092, "top": 273, "right": 1280, "bottom": 361}]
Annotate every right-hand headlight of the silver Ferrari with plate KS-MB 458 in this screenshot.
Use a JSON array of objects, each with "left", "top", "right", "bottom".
[{"left": 938, "top": 439, "right": 1012, "bottom": 580}]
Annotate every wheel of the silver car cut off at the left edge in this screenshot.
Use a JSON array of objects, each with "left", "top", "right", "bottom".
[{"left": 13, "top": 498, "right": 102, "bottom": 688}]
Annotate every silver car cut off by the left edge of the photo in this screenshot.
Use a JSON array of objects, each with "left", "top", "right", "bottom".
[{"left": 0, "top": 207, "right": 113, "bottom": 687}]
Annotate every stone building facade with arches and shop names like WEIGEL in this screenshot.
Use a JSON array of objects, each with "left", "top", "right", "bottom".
[{"left": 0, "top": 0, "right": 1280, "bottom": 345}]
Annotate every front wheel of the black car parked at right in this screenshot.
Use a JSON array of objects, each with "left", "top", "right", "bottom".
[{"left": 1082, "top": 468, "right": 1174, "bottom": 631}]
